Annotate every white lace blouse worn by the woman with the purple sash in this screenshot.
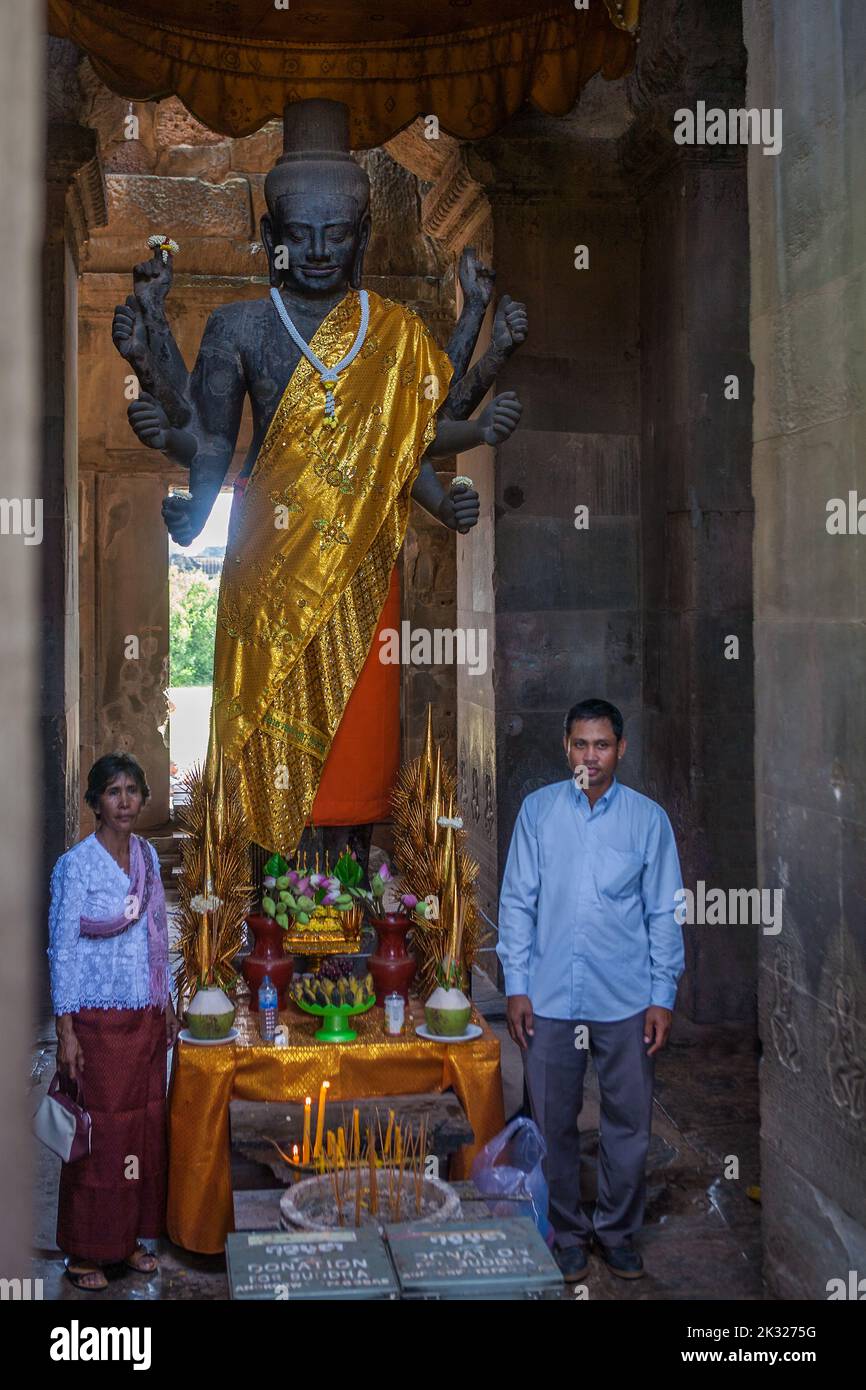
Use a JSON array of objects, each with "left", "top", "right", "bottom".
[{"left": 47, "top": 834, "right": 167, "bottom": 1015}]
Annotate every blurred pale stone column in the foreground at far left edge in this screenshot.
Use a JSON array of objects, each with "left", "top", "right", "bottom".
[{"left": 0, "top": 0, "right": 41, "bottom": 1279}]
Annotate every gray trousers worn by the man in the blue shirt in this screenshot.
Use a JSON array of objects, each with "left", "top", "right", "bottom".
[{"left": 524, "top": 1009, "right": 655, "bottom": 1250}]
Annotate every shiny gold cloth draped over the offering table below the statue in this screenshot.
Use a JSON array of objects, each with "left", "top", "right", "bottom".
[{"left": 167, "top": 999, "right": 505, "bottom": 1255}]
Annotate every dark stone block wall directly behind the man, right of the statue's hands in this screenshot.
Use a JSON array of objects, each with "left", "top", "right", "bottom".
[{"left": 467, "top": 92, "right": 641, "bottom": 973}]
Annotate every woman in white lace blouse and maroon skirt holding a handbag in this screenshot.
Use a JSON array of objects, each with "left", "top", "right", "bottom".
[{"left": 49, "top": 753, "right": 178, "bottom": 1291}]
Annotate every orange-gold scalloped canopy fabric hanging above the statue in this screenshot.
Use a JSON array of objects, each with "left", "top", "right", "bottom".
[{"left": 49, "top": 0, "right": 639, "bottom": 149}]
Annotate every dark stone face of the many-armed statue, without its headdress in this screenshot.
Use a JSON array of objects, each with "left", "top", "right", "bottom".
[{"left": 271, "top": 193, "right": 367, "bottom": 295}]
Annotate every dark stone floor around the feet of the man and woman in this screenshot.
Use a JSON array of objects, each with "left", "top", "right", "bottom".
[{"left": 32, "top": 976, "right": 766, "bottom": 1301}]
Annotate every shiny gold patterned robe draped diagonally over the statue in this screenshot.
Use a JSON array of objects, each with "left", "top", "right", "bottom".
[{"left": 209, "top": 291, "right": 452, "bottom": 855}]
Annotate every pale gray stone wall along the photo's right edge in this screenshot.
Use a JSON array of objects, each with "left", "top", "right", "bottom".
[{"left": 744, "top": 0, "right": 866, "bottom": 1298}]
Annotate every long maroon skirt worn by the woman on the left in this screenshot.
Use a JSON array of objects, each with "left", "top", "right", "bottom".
[{"left": 57, "top": 1008, "right": 167, "bottom": 1264}]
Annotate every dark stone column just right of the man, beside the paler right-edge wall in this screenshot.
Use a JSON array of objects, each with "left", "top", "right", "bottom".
[{"left": 621, "top": 0, "right": 756, "bottom": 1027}]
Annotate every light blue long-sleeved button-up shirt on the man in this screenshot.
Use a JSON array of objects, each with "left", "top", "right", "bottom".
[{"left": 496, "top": 777, "right": 684, "bottom": 1023}]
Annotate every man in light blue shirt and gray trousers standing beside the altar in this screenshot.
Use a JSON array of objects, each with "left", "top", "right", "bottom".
[{"left": 496, "top": 699, "right": 684, "bottom": 1282}]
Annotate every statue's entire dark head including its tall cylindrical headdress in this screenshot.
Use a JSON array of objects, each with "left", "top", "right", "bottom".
[{"left": 261, "top": 101, "right": 370, "bottom": 296}]
